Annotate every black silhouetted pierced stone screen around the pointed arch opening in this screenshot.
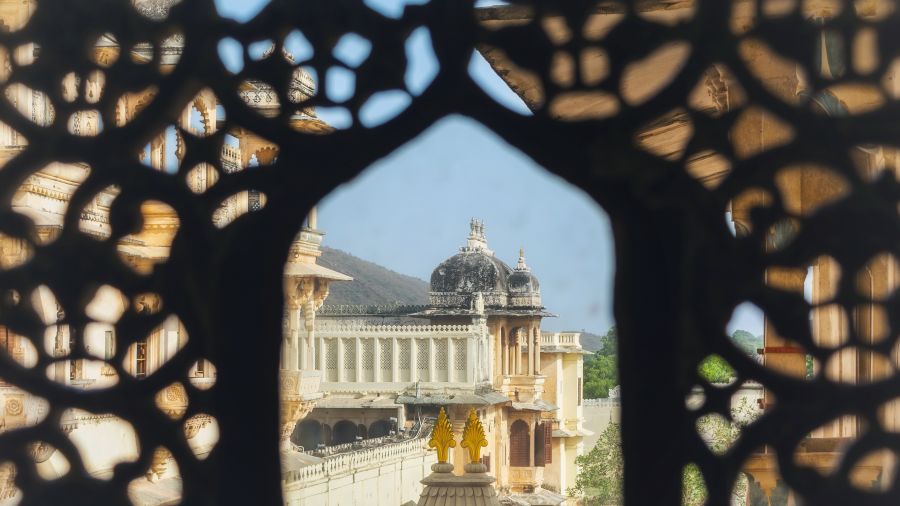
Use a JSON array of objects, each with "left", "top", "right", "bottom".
[{"left": 0, "top": 0, "right": 900, "bottom": 505}]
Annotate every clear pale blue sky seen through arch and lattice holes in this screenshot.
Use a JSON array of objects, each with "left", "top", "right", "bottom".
[{"left": 216, "top": 0, "right": 762, "bottom": 334}]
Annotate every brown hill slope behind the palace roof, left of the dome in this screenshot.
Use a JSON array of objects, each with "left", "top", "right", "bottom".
[{"left": 317, "top": 247, "right": 428, "bottom": 305}]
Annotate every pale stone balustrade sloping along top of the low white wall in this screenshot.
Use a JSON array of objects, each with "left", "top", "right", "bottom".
[{"left": 282, "top": 437, "right": 428, "bottom": 484}]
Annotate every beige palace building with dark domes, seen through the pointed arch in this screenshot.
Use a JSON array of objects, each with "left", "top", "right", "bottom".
[{"left": 293, "top": 220, "right": 589, "bottom": 504}]
